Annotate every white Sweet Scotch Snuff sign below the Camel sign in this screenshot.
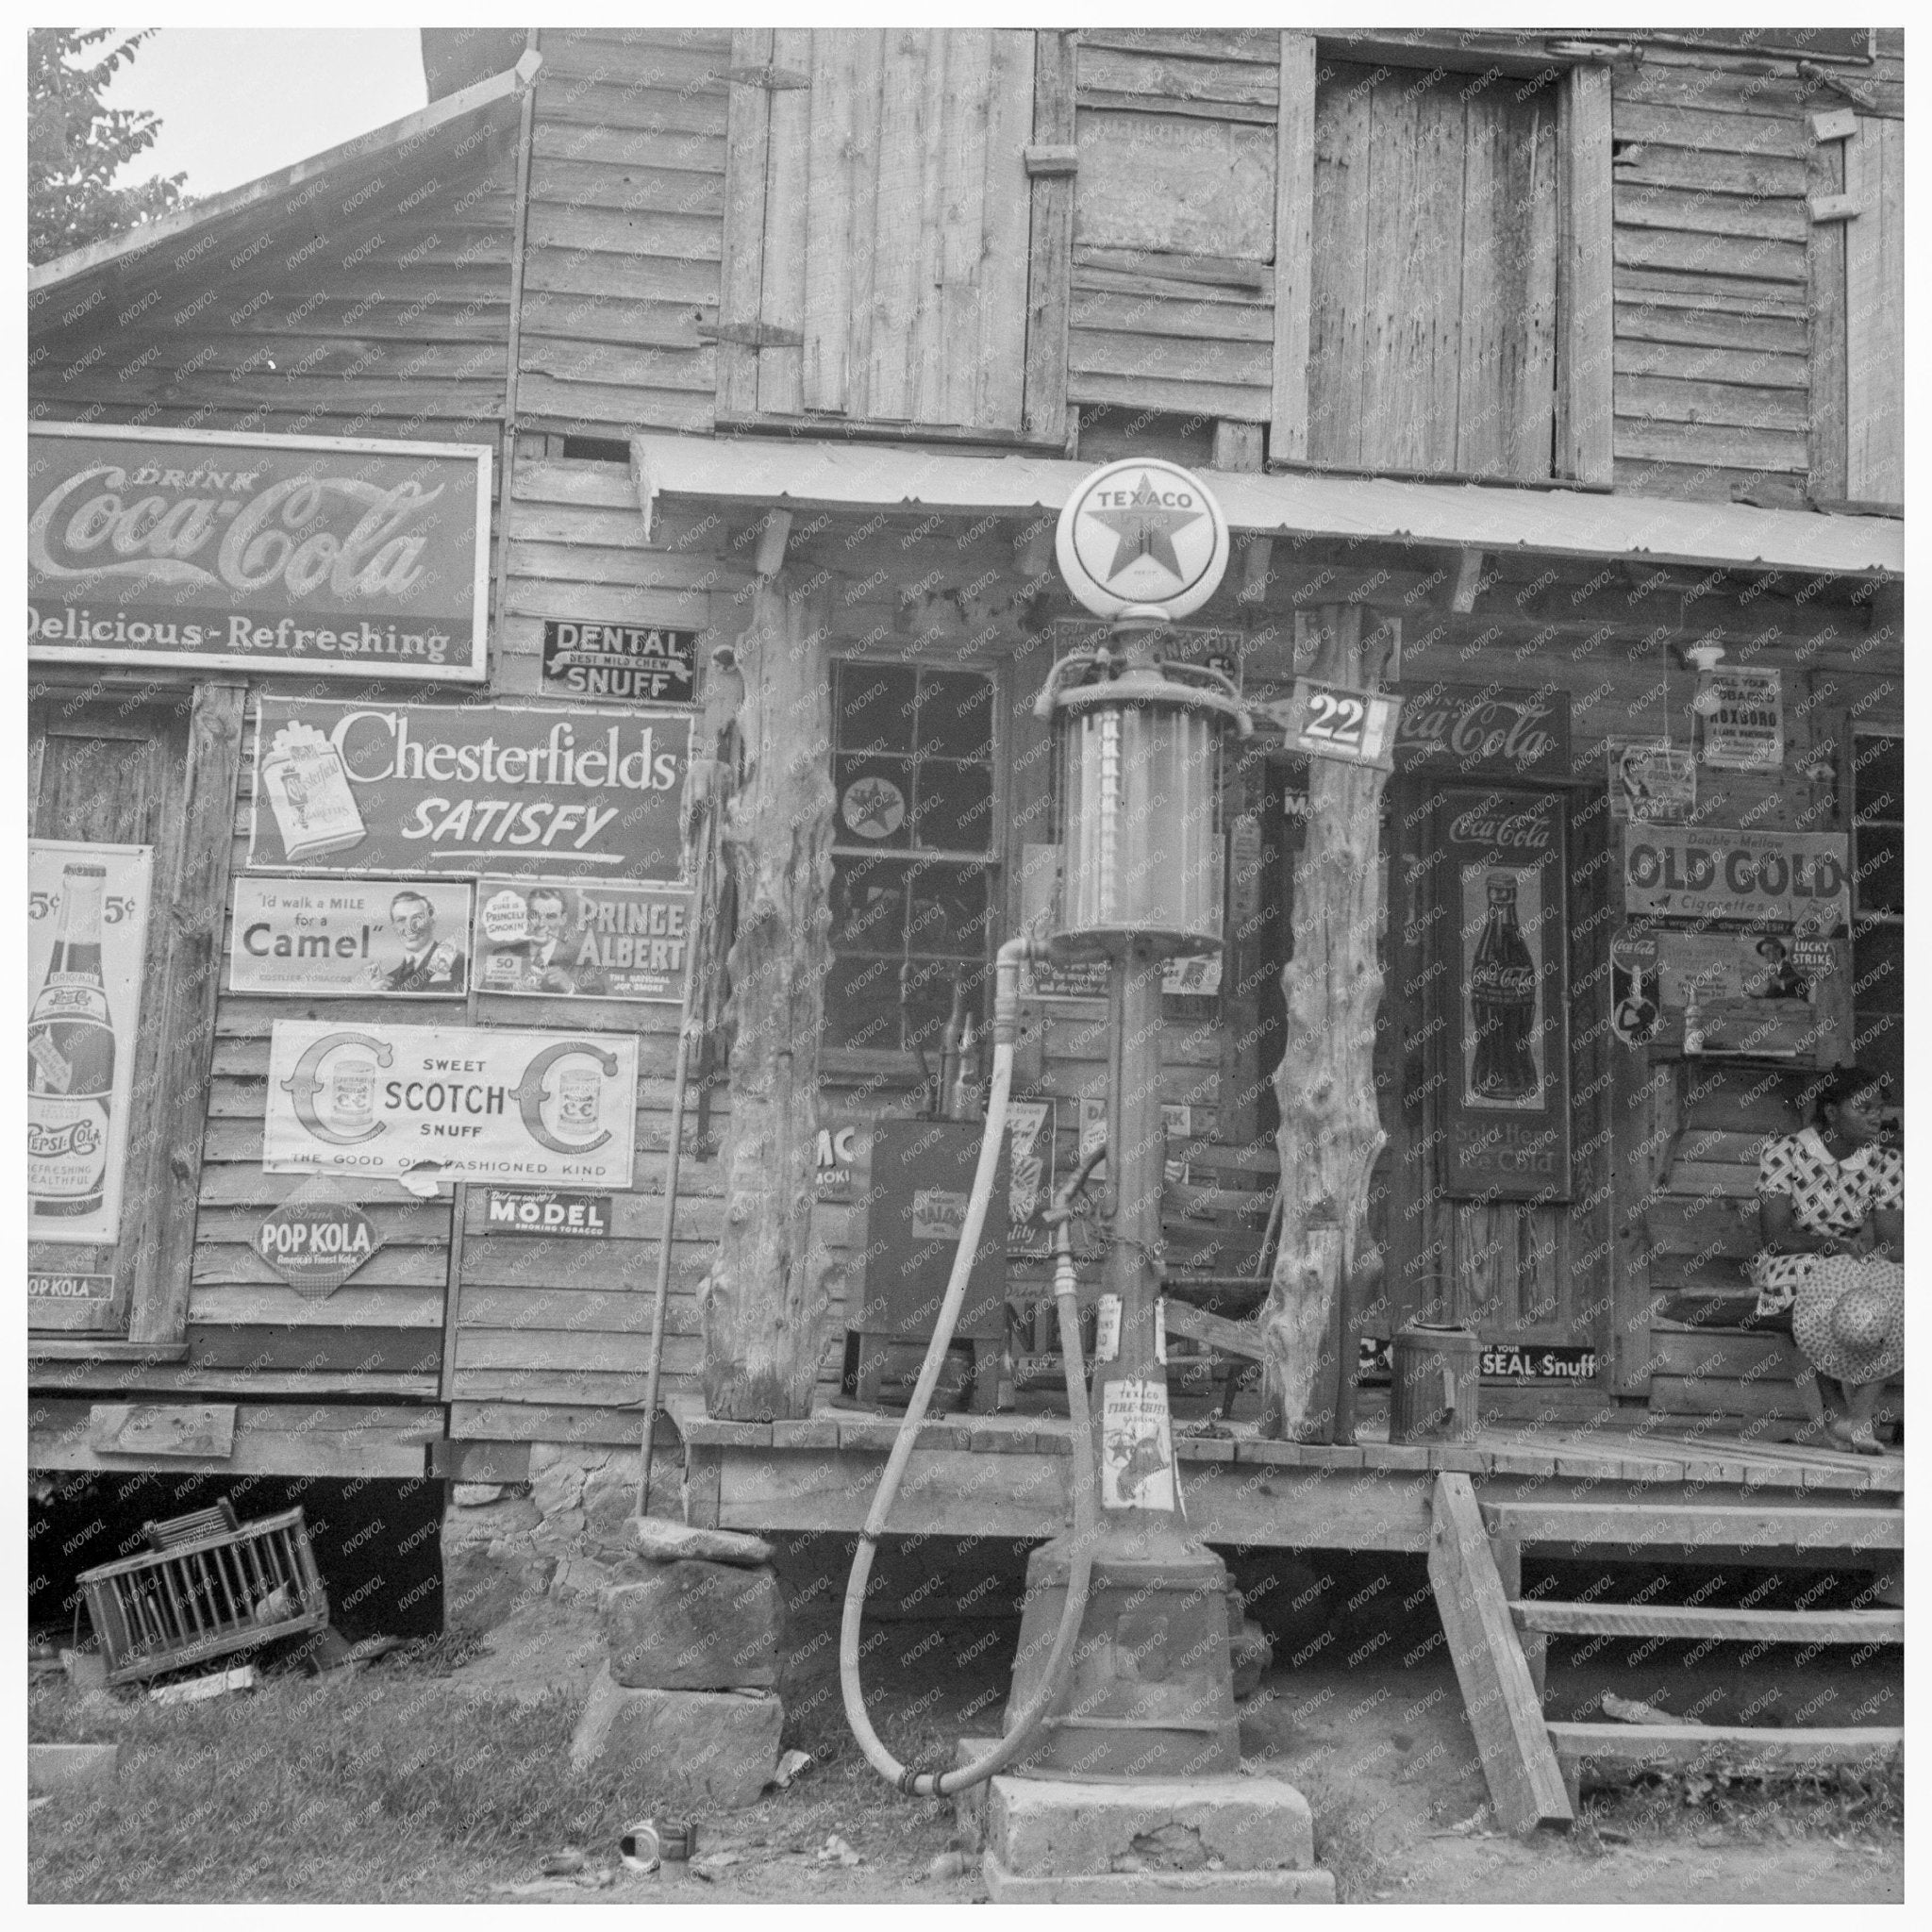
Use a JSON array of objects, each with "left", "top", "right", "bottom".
[{"left": 263, "top": 1020, "right": 638, "bottom": 1189}]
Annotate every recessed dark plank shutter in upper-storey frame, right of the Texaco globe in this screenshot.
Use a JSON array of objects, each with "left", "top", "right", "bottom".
[{"left": 1307, "top": 62, "right": 1559, "bottom": 477}]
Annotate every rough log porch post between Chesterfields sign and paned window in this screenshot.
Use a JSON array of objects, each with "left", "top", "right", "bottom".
[{"left": 697, "top": 574, "right": 833, "bottom": 1422}]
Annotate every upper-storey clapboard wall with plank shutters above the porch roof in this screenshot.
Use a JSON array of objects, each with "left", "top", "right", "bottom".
[{"left": 498, "top": 29, "right": 1903, "bottom": 502}]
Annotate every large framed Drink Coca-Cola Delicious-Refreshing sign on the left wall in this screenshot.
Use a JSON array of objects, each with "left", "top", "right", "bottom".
[{"left": 27, "top": 425, "right": 491, "bottom": 682}]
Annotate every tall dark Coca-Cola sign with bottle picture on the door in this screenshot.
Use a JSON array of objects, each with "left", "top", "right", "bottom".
[{"left": 1438, "top": 789, "right": 1571, "bottom": 1200}]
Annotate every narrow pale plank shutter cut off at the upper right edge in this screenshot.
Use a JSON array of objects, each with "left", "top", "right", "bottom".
[{"left": 1845, "top": 114, "right": 1905, "bottom": 502}]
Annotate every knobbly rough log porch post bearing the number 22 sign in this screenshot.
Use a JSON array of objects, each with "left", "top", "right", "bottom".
[{"left": 1261, "top": 605, "right": 1387, "bottom": 1441}]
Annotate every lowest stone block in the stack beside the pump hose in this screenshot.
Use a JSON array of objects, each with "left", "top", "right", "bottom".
[{"left": 570, "top": 1665, "right": 784, "bottom": 1810}]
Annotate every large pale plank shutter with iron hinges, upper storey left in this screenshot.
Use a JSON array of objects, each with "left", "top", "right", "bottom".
[{"left": 719, "top": 27, "right": 1064, "bottom": 437}]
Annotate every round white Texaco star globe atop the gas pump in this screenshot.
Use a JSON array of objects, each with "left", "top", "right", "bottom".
[{"left": 1057, "top": 458, "right": 1226, "bottom": 618}]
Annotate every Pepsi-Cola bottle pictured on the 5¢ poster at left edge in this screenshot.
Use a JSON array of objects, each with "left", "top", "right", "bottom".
[{"left": 27, "top": 863, "right": 114, "bottom": 1219}]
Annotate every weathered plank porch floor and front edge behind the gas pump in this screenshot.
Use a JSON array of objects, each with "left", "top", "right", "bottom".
[{"left": 671, "top": 1397, "right": 1905, "bottom": 1556}]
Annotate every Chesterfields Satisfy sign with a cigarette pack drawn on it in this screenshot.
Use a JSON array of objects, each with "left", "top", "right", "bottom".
[{"left": 247, "top": 695, "right": 691, "bottom": 879}]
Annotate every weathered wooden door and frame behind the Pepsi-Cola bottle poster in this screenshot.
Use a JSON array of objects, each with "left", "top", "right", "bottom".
[{"left": 27, "top": 699, "right": 188, "bottom": 1335}]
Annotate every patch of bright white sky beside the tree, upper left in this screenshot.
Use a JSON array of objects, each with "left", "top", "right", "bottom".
[{"left": 103, "top": 27, "right": 427, "bottom": 195}]
